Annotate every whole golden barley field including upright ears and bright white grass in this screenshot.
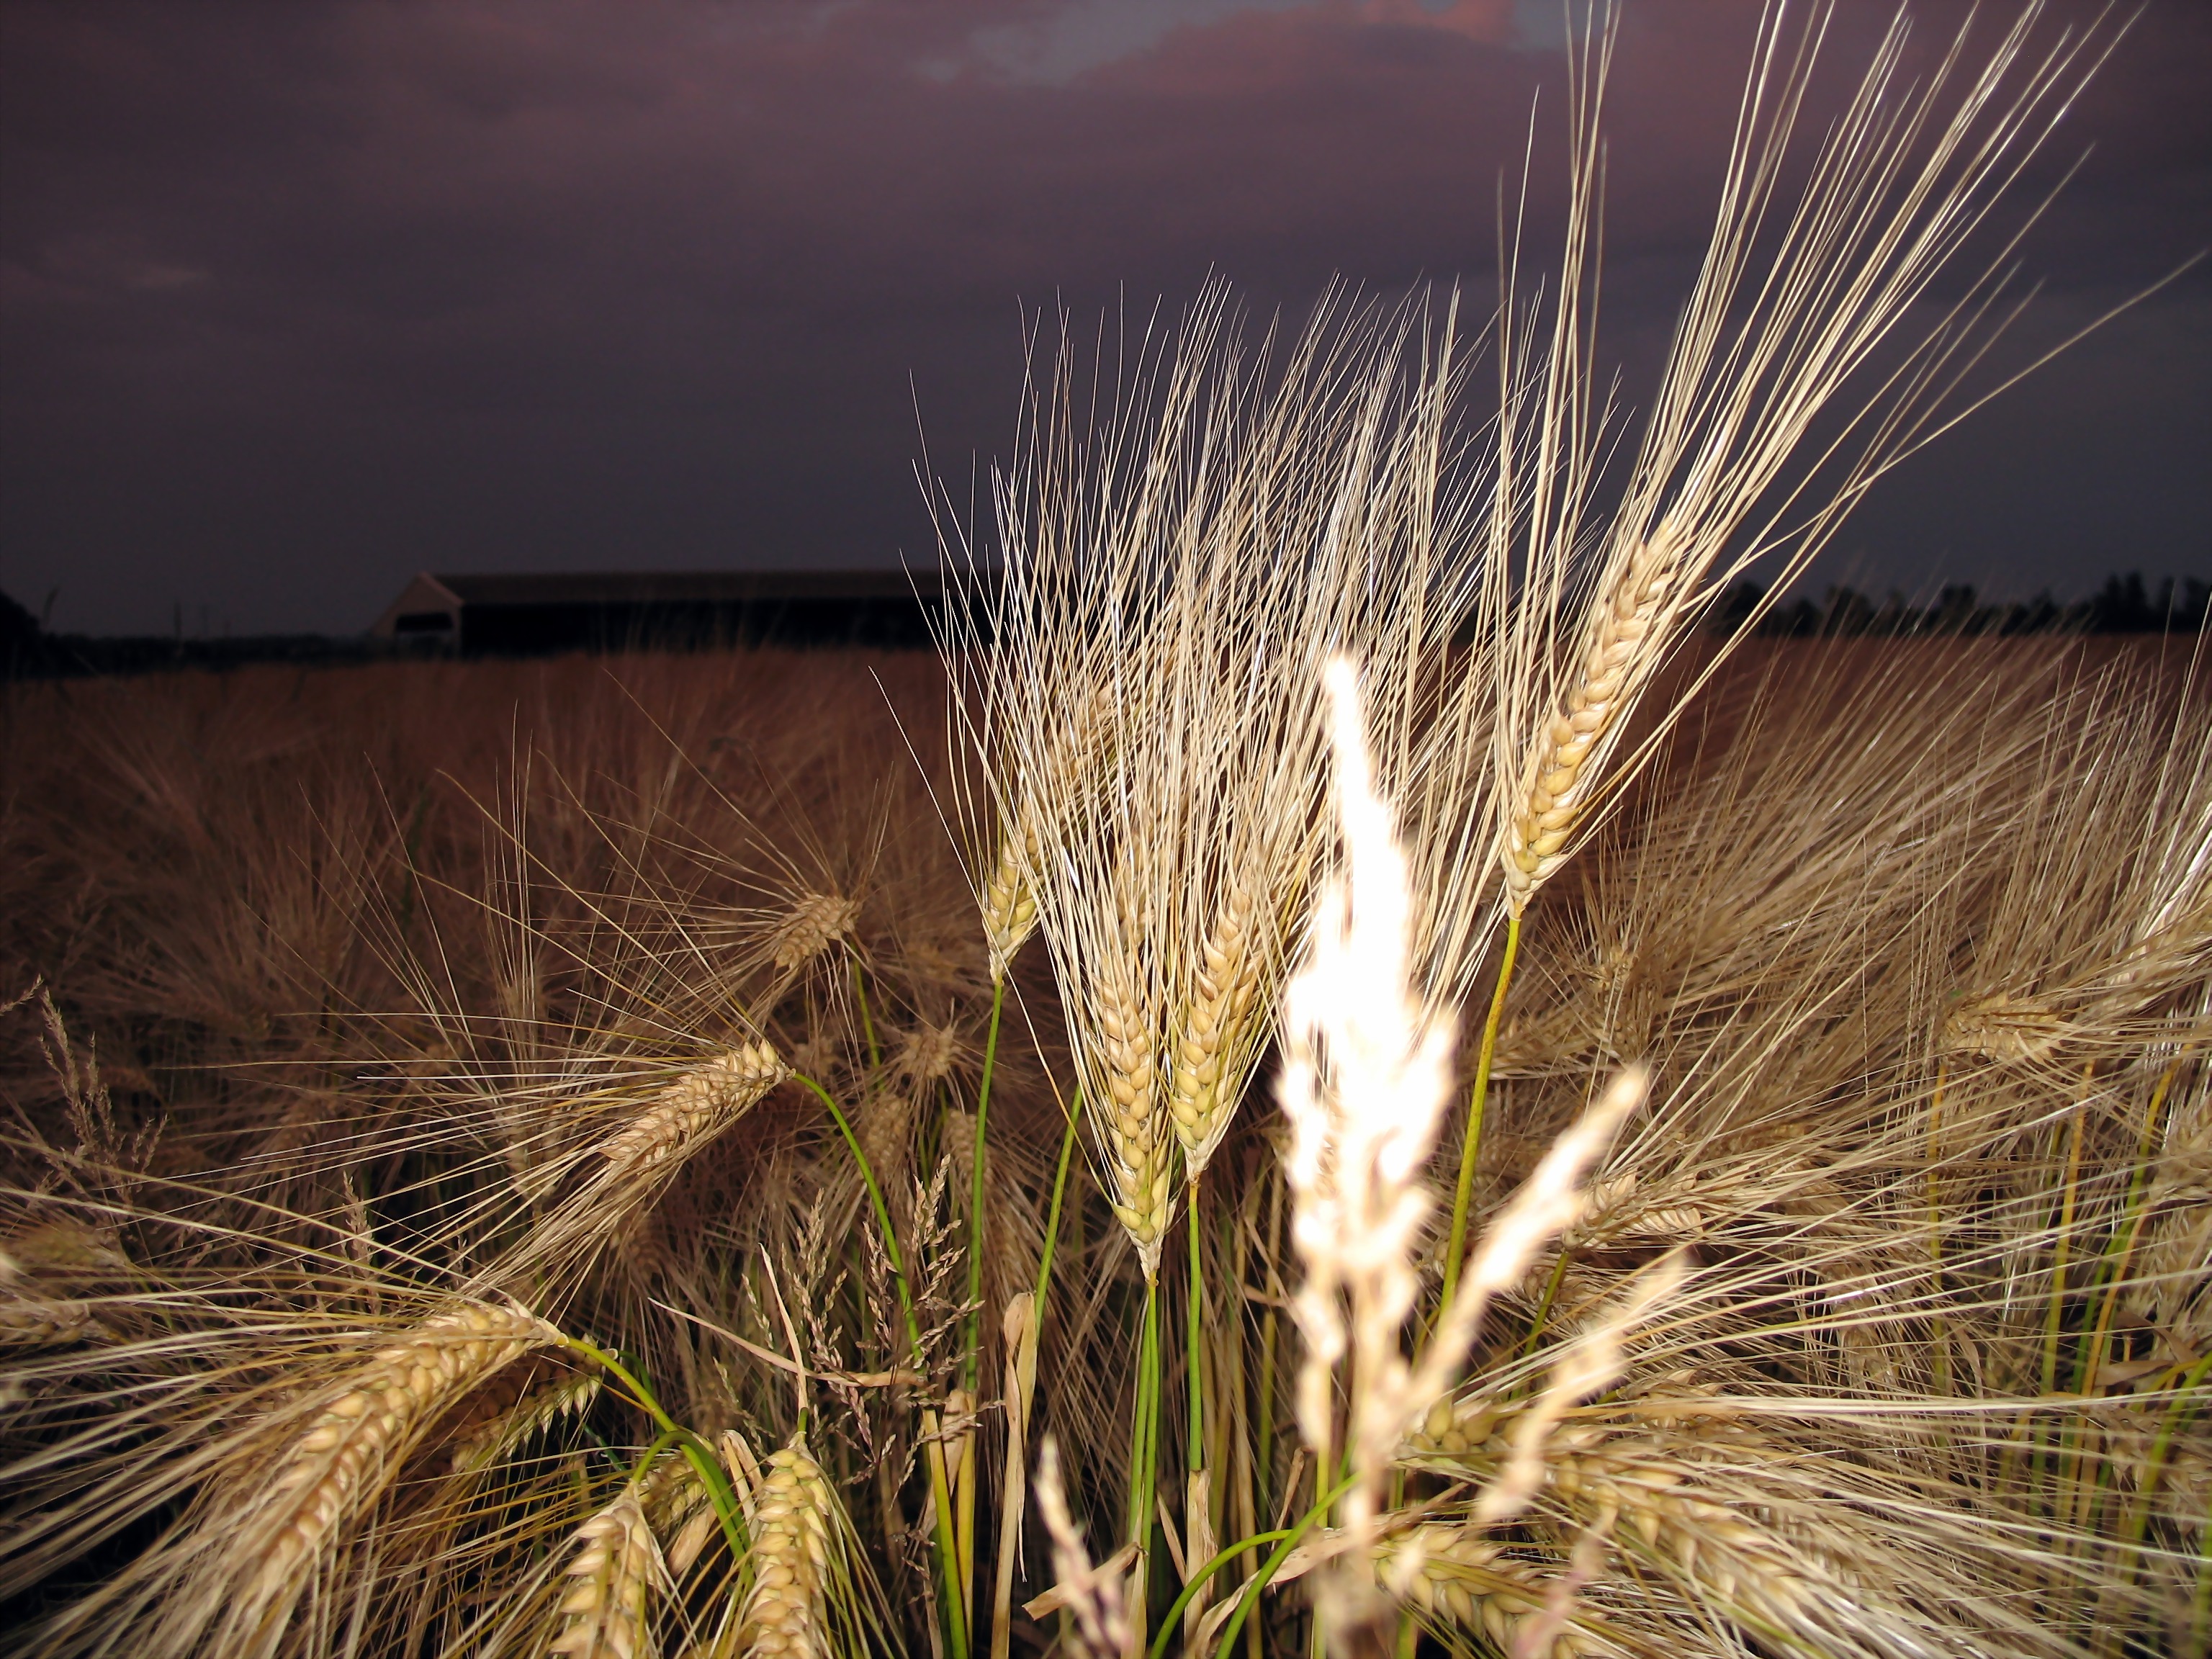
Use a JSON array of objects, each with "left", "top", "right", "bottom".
[{"left": 0, "top": 11, "right": 2212, "bottom": 1659}]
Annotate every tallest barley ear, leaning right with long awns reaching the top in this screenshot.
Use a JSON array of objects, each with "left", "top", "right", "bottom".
[{"left": 1488, "top": 4, "right": 2126, "bottom": 938}]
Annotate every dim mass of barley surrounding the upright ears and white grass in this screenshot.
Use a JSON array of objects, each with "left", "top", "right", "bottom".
[{"left": 4, "top": 642, "right": 2212, "bottom": 1653}]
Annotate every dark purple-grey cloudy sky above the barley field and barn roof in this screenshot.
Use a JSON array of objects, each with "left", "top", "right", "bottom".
[{"left": 0, "top": 0, "right": 2212, "bottom": 633}]
